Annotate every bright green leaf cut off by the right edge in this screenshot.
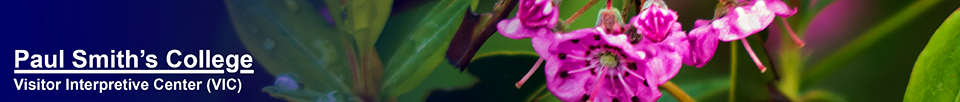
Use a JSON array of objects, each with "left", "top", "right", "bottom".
[{"left": 903, "top": 8, "right": 960, "bottom": 102}]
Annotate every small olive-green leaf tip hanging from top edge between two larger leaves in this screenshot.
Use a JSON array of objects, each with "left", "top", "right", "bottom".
[{"left": 324, "top": 0, "right": 393, "bottom": 52}]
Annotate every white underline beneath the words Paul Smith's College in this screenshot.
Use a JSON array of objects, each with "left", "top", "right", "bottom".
[{"left": 13, "top": 69, "right": 253, "bottom": 74}]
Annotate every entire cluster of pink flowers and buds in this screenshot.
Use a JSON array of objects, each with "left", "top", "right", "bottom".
[{"left": 497, "top": 0, "right": 796, "bottom": 102}]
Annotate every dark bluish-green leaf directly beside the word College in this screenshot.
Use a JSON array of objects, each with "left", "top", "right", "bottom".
[{"left": 225, "top": 0, "right": 355, "bottom": 98}]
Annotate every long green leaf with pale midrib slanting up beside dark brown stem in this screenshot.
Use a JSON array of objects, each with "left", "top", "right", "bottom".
[{"left": 382, "top": 0, "right": 470, "bottom": 98}]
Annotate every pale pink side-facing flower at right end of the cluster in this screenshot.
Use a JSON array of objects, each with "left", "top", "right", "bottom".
[{"left": 684, "top": 0, "right": 802, "bottom": 72}]
